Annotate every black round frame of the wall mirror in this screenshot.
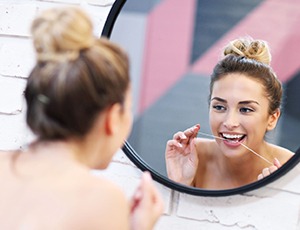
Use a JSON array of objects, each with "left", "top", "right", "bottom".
[{"left": 101, "top": 0, "right": 300, "bottom": 197}]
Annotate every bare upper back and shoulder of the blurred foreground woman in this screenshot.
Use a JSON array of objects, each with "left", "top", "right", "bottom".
[{"left": 0, "top": 152, "right": 129, "bottom": 230}]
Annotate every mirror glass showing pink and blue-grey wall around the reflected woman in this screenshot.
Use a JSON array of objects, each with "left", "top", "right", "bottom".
[{"left": 110, "top": 0, "right": 300, "bottom": 193}]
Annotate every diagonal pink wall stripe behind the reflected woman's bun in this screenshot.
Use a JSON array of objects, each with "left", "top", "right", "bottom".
[{"left": 192, "top": 0, "right": 300, "bottom": 82}]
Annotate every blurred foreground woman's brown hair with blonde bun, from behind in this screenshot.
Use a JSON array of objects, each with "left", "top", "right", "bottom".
[{"left": 25, "top": 7, "right": 130, "bottom": 139}]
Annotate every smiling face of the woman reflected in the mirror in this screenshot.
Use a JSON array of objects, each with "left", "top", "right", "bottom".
[{"left": 209, "top": 73, "right": 278, "bottom": 157}]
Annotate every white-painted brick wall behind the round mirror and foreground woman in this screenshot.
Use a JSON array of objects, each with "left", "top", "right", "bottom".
[{"left": 0, "top": 0, "right": 300, "bottom": 230}]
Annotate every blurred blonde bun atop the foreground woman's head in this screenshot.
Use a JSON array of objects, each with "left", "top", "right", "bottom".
[{"left": 31, "top": 7, "right": 95, "bottom": 61}]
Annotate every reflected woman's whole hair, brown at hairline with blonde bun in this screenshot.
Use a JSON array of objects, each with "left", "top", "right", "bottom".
[{"left": 210, "top": 37, "right": 282, "bottom": 114}]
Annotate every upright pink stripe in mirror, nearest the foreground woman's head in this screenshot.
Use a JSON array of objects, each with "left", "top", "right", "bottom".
[{"left": 139, "top": 0, "right": 195, "bottom": 112}]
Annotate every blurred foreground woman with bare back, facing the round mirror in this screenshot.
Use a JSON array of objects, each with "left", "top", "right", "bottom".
[{"left": 0, "top": 8, "right": 163, "bottom": 230}]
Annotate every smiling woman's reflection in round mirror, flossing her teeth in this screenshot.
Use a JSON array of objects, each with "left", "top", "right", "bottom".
[{"left": 165, "top": 38, "right": 293, "bottom": 189}]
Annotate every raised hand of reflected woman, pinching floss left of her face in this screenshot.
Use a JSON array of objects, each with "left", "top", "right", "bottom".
[{"left": 165, "top": 124, "right": 200, "bottom": 185}]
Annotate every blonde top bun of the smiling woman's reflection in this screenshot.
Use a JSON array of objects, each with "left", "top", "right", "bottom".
[{"left": 224, "top": 37, "right": 271, "bottom": 65}]
